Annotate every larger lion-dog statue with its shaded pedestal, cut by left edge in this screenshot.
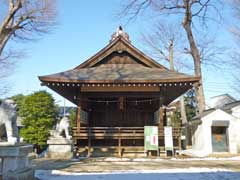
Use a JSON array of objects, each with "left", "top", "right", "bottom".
[{"left": 0, "top": 99, "right": 34, "bottom": 180}]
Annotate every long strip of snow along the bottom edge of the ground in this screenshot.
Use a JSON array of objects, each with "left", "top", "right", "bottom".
[{"left": 35, "top": 168, "right": 240, "bottom": 180}]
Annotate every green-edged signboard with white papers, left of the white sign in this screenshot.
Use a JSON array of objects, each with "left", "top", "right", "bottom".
[{"left": 144, "top": 126, "right": 158, "bottom": 151}]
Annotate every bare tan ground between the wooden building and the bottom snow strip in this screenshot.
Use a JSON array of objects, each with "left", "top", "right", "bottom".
[{"left": 32, "top": 158, "right": 240, "bottom": 173}]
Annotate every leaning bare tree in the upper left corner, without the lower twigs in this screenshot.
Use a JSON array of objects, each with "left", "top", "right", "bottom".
[{"left": 0, "top": 0, "right": 55, "bottom": 56}]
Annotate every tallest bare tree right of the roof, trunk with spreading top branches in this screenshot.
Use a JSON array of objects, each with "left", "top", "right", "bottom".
[{"left": 122, "top": 0, "right": 220, "bottom": 112}]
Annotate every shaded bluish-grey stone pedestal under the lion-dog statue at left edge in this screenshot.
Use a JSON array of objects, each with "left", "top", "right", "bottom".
[{"left": 0, "top": 143, "right": 34, "bottom": 180}]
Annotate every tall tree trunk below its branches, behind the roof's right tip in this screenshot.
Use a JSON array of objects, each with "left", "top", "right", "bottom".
[{"left": 183, "top": 19, "right": 205, "bottom": 113}]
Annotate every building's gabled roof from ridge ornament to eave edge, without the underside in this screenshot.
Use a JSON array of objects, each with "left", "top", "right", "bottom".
[{"left": 39, "top": 29, "right": 199, "bottom": 83}]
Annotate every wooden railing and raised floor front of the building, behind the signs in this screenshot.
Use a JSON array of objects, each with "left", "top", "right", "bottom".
[{"left": 72, "top": 127, "right": 181, "bottom": 157}]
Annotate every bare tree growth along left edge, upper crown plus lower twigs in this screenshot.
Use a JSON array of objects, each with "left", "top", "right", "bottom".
[{"left": 0, "top": 0, "right": 56, "bottom": 95}]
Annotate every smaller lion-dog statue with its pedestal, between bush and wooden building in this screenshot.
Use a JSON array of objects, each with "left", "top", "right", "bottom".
[{"left": 46, "top": 116, "right": 73, "bottom": 159}]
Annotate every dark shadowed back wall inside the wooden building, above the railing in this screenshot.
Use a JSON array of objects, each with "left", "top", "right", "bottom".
[{"left": 89, "top": 100, "right": 154, "bottom": 127}]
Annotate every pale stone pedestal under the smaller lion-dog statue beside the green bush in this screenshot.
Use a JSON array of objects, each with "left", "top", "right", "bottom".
[{"left": 46, "top": 137, "right": 73, "bottom": 159}]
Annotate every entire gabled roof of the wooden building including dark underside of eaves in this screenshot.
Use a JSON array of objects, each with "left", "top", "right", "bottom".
[{"left": 39, "top": 26, "right": 200, "bottom": 105}]
